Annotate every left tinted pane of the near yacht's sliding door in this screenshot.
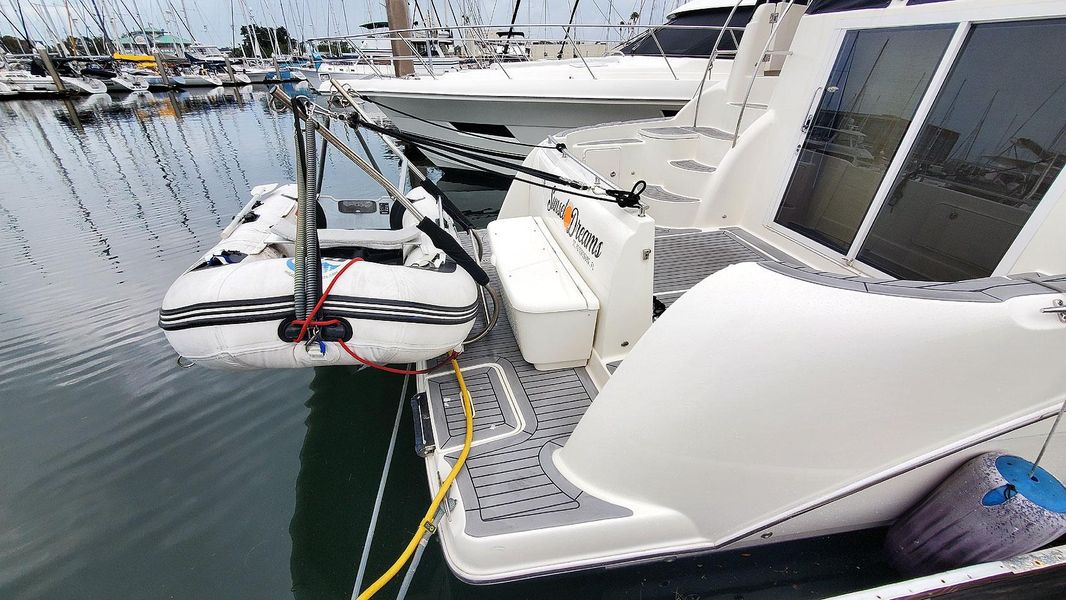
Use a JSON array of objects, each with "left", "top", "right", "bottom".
[{"left": 774, "top": 25, "right": 956, "bottom": 254}]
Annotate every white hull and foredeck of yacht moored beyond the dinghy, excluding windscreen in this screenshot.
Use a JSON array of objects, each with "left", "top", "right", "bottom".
[{"left": 346, "top": 56, "right": 731, "bottom": 175}]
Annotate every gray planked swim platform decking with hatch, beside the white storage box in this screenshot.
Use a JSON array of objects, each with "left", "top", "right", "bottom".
[{"left": 427, "top": 232, "right": 631, "bottom": 537}]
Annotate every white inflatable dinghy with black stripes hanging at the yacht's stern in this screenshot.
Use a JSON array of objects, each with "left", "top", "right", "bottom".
[{"left": 159, "top": 184, "right": 479, "bottom": 369}]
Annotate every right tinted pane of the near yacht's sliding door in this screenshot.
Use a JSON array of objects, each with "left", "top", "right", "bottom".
[{"left": 858, "top": 19, "right": 1066, "bottom": 281}]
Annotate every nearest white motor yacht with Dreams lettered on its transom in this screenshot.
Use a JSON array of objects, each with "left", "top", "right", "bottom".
[{"left": 405, "top": 0, "right": 1066, "bottom": 598}]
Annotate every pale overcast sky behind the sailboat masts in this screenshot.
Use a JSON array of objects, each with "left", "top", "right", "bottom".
[{"left": 0, "top": 0, "right": 682, "bottom": 46}]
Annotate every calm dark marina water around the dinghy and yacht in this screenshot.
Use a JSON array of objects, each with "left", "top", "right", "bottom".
[{"left": 0, "top": 87, "right": 893, "bottom": 599}]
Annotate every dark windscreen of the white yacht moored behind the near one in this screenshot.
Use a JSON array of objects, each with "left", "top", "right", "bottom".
[{"left": 619, "top": 6, "right": 755, "bottom": 59}]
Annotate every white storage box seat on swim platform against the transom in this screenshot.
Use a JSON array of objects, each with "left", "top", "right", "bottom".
[{"left": 488, "top": 216, "right": 599, "bottom": 371}]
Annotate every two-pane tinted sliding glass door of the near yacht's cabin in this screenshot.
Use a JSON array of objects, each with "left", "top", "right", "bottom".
[{"left": 774, "top": 19, "right": 1066, "bottom": 281}]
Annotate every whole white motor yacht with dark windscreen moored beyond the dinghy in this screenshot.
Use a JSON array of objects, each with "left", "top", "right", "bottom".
[{"left": 349, "top": 0, "right": 758, "bottom": 173}]
